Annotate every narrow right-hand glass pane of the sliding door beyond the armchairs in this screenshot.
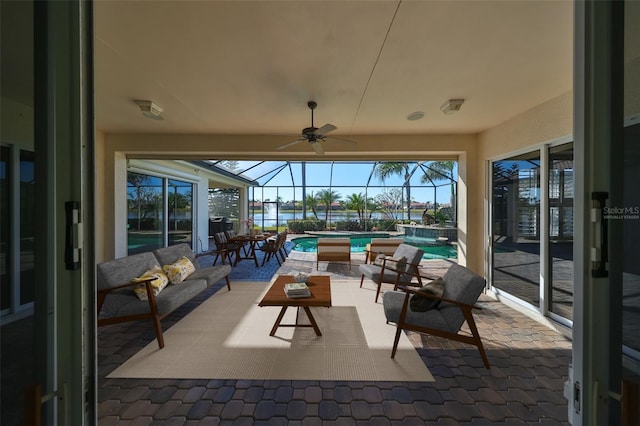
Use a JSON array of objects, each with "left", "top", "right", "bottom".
[{"left": 549, "top": 143, "right": 574, "bottom": 319}]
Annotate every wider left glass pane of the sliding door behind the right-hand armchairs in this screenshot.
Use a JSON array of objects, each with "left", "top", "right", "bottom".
[{"left": 491, "top": 151, "right": 540, "bottom": 306}]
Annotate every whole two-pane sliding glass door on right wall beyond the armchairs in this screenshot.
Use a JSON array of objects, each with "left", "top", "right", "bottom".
[{"left": 491, "top": 143, "right": 574, "bottom": 321}]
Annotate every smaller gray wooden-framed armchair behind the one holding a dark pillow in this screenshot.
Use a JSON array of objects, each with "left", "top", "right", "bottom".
[{"left": 358, "top": 244, "right": 424, "bottom": 303}]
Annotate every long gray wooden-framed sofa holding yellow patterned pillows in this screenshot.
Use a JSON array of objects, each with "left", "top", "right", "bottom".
[{"left": 97, "top": 244, "right": 231, "bottom": 348}]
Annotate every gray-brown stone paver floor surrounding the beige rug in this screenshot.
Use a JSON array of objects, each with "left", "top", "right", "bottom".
[{"left": 98, "top": 253, "right": 571, "bottom": 426}]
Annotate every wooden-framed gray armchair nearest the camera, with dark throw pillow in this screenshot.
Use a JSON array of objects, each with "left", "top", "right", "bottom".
[{"left": 382, "top": 264, "right": 490, "bottom": 368}]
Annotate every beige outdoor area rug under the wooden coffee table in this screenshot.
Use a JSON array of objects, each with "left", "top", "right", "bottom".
[{"left": 108, "top": 280, "right": 433, "bottom": 382}]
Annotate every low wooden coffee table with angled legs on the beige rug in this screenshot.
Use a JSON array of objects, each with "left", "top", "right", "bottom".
[{"left": 258, "top": 275, "right": 331, "bottom": 336}]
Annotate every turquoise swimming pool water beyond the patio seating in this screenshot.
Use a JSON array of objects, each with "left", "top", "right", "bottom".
[{"left": 291, "top": 235, "right": 458, "bottom": 259}]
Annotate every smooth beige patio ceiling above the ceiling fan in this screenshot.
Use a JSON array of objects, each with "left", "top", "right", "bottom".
[{"left": 95, "top": 0, "right": 573, "bottom": 137}]
